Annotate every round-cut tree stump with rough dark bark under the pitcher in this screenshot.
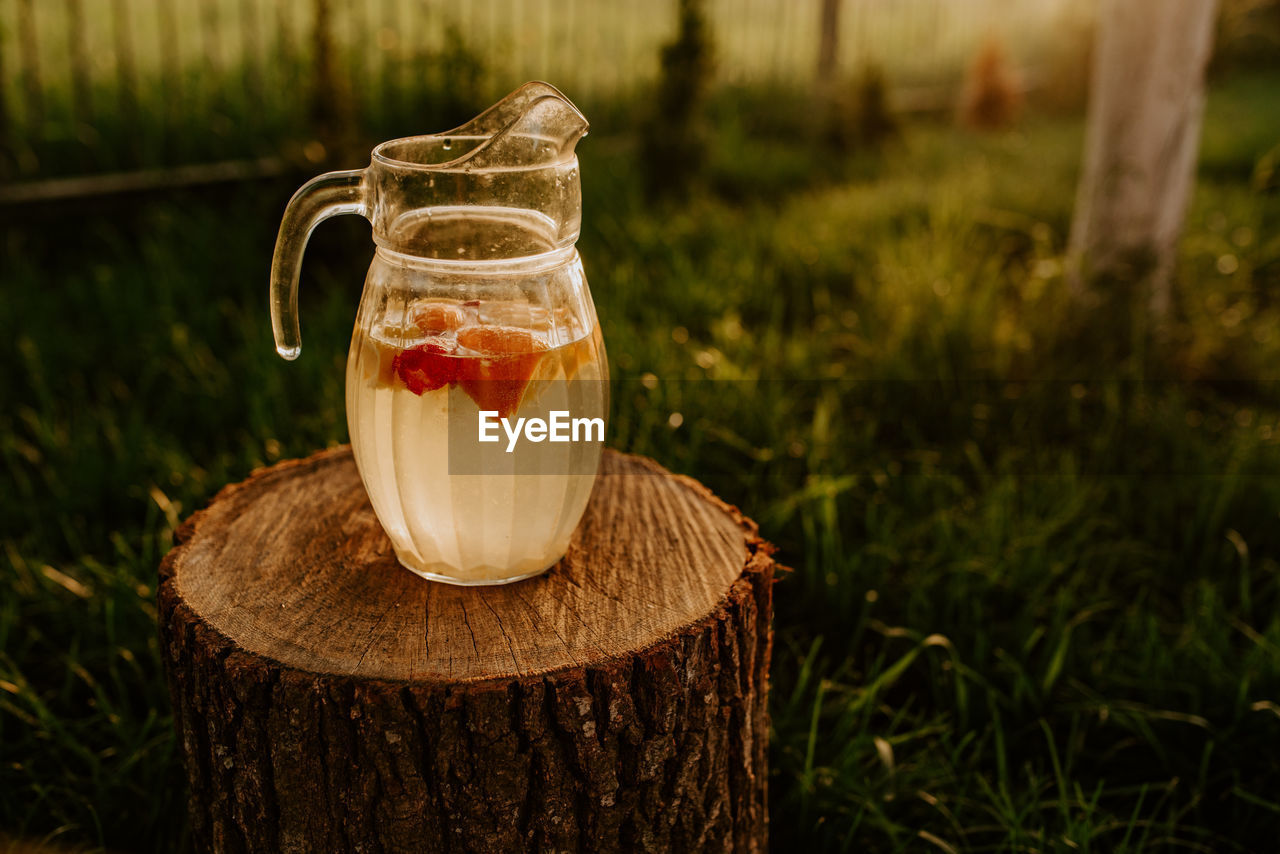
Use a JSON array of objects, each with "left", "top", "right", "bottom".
[{"left": 159, "top": 448, "right": 774, "bottom": 851}]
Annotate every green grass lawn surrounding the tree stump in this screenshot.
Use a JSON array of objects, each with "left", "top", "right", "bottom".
[{"left": 0, "top": 74, "right": 1280, "bottom": 851}]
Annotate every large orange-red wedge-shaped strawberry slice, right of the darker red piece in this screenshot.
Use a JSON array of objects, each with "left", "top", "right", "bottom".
[{"left": 457, "top": 326, "right": 547, "bottom": 419}]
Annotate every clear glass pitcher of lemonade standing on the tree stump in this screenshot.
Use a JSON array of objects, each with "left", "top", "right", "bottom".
[{"left": 271, "top": 83, "right": 608, "bottom": 584}]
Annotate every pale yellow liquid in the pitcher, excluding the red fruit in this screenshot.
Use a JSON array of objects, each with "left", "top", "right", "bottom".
[{"left": 347, "top": 317, "right": 608, "bottom": 584}]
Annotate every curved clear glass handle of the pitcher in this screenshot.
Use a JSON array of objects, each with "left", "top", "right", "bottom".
[{"left": 271, "top": 169, "right": 369, "bottom": 360}]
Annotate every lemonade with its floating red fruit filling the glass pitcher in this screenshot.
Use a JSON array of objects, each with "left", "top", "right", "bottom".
[{"left": 347, "top": 300, "right": 608, "bottom": 584}]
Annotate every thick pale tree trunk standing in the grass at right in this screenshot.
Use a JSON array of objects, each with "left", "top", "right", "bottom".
[{"left": 1070, "top": 0, "right": 1217, "bottom": 318}]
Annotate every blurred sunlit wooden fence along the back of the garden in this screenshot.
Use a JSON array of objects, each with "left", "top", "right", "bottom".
[{"left": 0, "top": 0, "right": 1091, "bottom": 179}]
